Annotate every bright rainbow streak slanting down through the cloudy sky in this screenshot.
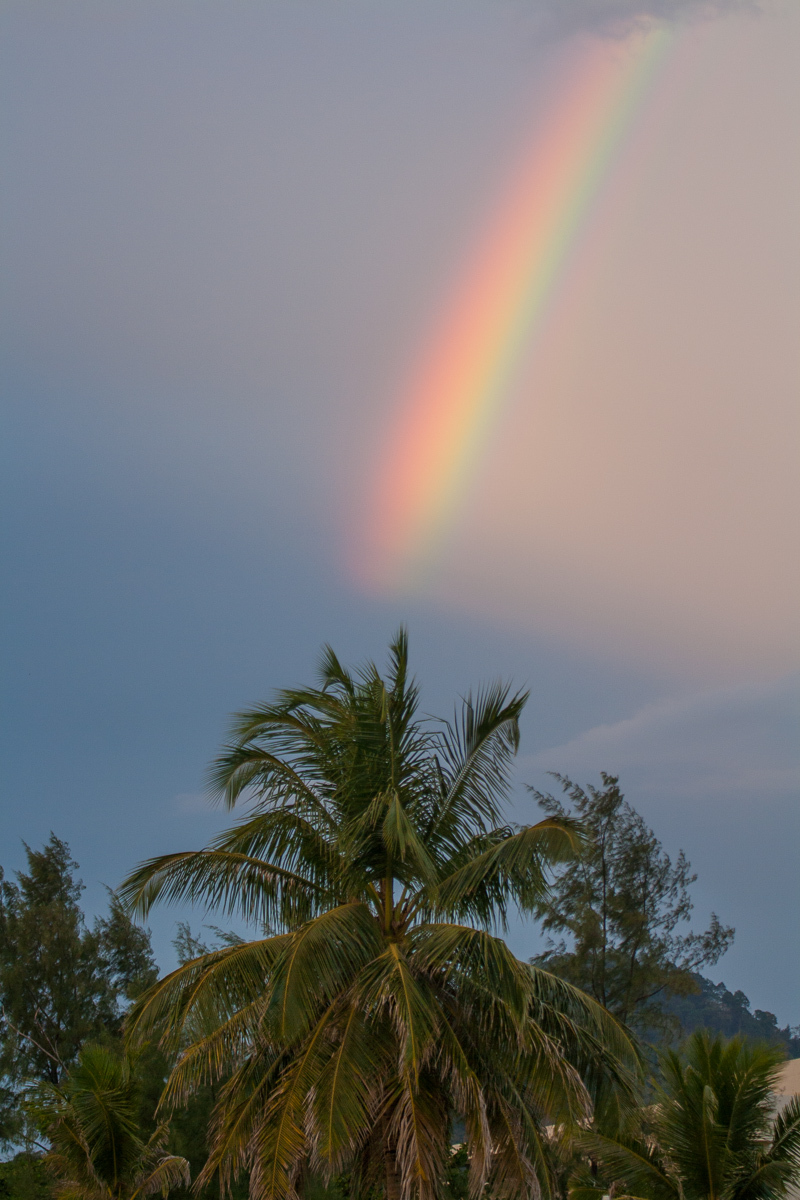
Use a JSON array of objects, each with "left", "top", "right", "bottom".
[{"left": 357, "top": 30, "right": 672, "bottom": 589}]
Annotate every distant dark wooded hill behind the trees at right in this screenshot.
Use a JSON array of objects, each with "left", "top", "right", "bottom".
[{"left": 663, "top": 974, "right": 800, "bottom": 1058}]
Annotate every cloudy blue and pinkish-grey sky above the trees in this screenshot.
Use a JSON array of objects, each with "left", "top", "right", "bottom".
[{"left": 0, "top": 0, "right": 800, "bottom": 1025}]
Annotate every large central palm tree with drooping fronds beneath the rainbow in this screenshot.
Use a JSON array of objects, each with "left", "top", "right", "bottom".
[{"left": 125, "top": 631, "right": 636, "bottom": 1200}]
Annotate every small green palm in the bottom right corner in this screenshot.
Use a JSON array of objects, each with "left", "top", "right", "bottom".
[{"left": 570, "top": 1031, "right": 800, "bottom": 1200}]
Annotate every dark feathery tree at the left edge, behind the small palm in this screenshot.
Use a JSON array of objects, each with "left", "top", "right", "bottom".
[{"left": 0, "top": 834, "right": 157, "bottom": 1144}]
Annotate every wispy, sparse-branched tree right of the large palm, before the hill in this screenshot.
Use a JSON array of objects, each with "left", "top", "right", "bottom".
[{"left": 530, "top": 773, "right": 734, "bottom": 1031}]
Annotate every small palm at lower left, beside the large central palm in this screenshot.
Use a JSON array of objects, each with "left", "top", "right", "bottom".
[{"left": 37, "top": 1045, "right": 190, "bottom": 1200}]
